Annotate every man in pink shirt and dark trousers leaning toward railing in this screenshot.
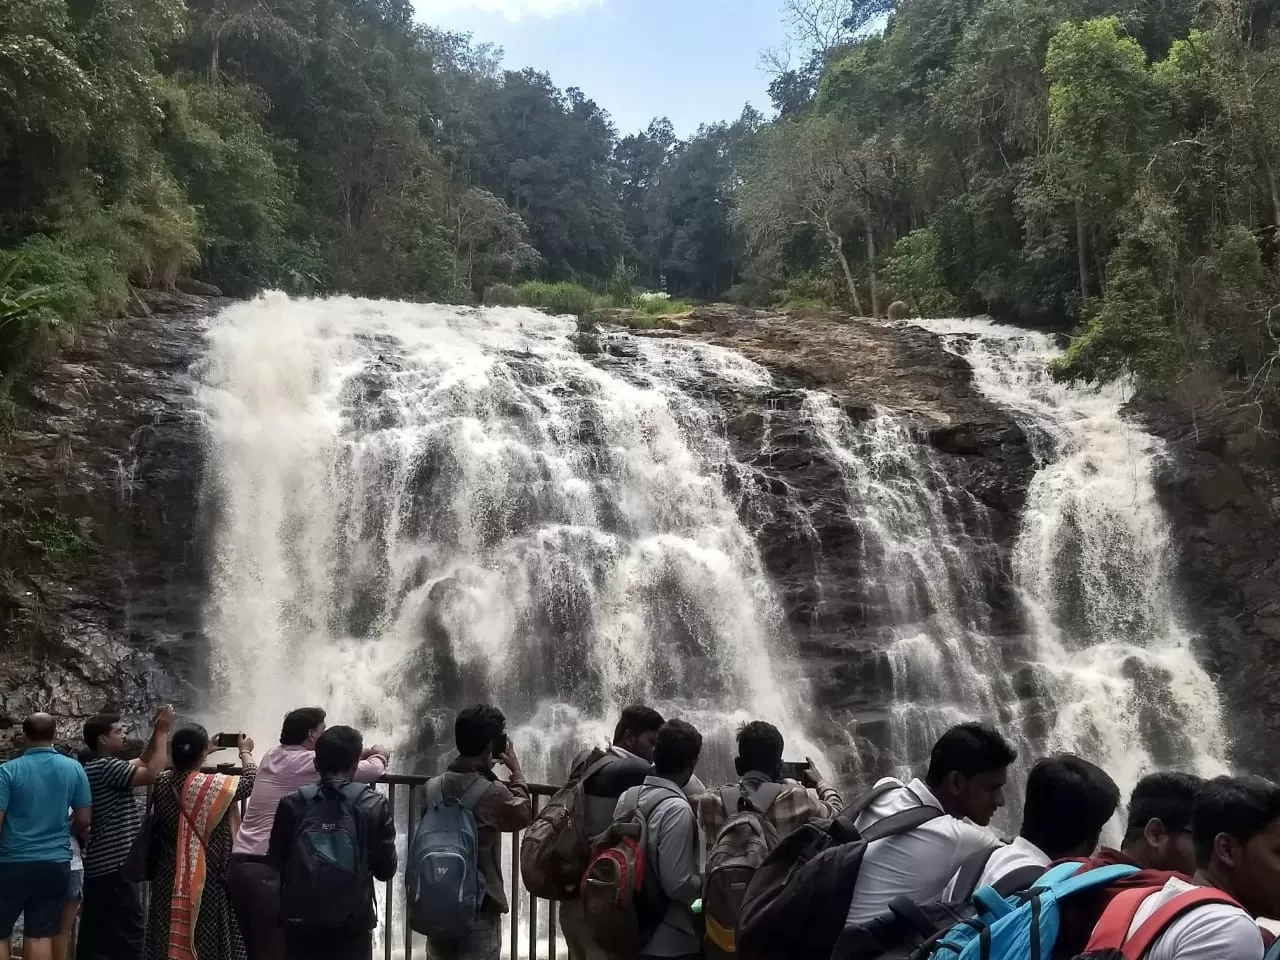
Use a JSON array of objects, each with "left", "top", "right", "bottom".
[{"left": 227, "top": 707, "right": 390, "bottom": 960}]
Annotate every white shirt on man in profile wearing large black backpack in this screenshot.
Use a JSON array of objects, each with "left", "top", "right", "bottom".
[{"left": 846, "top": 777, "right": 1000, "bottom": 923}]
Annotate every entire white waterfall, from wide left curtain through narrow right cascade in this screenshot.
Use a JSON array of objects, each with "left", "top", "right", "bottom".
[{"left": 195, "top": 294, "right": 1226, "bottom": 810}]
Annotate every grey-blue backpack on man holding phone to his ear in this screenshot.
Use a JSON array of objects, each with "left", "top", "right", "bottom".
[{"left": 404, "top": 776, "right": 490, "bottom": 942}]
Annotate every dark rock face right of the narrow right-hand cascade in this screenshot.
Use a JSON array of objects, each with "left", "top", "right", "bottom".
[{"left": 1135, "top": 397, "right": 1280, "bottom": 777}]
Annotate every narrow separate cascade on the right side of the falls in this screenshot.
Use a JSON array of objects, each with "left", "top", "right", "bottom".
[{"left": 920, "top": 320, "right": 1226, "bottom": 788}]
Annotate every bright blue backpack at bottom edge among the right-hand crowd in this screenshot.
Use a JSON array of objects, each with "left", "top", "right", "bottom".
[{"left": 922, "top": 863, "right": 1138, "bottom": 960}]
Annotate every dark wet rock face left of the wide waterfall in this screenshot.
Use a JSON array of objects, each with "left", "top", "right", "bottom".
[{"left": 0, "top": 297, "right": 216, "bottom": 746}]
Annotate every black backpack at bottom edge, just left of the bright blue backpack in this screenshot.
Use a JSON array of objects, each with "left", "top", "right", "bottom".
[{"left": 831, "top": 847, "right": 1047, "bottom": 960}]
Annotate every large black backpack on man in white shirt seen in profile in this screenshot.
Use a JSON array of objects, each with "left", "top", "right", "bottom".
[{"left": 737, "top": 783, "right": 943, "bottom": 960}]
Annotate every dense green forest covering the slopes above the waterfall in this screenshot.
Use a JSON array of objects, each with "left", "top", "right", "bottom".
[{"left": 0, "top": 0, "right": 1280, "bottom": 406}]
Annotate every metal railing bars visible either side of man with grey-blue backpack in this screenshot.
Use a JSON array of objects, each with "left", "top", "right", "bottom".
[{"left": 378, "top": 773, "right": 559, "bottom": 960}]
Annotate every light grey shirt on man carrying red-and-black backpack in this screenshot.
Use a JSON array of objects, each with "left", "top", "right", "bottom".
[{"left": 616, "top": 776, "right": 703, "bottom": 956}]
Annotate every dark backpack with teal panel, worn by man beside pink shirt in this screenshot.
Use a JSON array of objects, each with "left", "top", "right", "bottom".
[{"left": 280, "top": 783, "right": 374, "bottom": 931}]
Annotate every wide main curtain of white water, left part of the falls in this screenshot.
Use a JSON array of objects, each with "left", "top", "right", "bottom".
[{"left": 197, "top": 294, "right": 819, "bottom": 776}]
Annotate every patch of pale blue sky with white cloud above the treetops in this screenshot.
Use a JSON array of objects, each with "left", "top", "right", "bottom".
[{"left": 416, "top": 0, "right": 786, "bottom": 137}]
